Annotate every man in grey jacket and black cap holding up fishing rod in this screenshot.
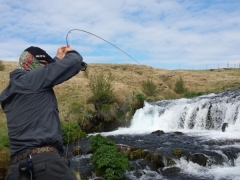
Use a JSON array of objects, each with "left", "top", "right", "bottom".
[{"left": 0, "top": 46, "right": 87, "bottom": 180}]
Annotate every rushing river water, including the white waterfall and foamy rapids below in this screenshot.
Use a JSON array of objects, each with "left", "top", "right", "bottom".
[{"left": 69, "top": 90, "right": 240, "bottom": 180}]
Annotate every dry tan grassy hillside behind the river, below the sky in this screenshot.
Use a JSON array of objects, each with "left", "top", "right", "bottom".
[{"left": 0, "top": 62, "right": 240, "bottom": 121}]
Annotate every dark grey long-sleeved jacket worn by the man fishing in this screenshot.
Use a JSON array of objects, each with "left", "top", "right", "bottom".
[{"left": 0, "top": 51, "right": 82, "bottom": 157}]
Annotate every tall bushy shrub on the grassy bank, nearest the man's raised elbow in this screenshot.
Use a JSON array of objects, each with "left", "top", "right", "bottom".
[{"left": 89, "top": 72, "right": 114, "bottom": 110}]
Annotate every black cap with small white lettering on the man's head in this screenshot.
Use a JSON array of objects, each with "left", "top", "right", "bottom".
[{"left": 24, "top": 46, "right": 55, "bottom": 63}]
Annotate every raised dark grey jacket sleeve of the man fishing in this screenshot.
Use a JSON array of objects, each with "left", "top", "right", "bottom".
[{"left": 26, "top": 50, "right": 83, "bottom": 91}]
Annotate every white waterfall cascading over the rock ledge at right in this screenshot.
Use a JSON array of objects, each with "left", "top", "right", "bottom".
[{"left": 129, "top": 90, "right": 240, "bottom": 132}]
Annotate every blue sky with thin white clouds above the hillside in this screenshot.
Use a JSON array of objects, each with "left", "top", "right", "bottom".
[{"left": 0, "top": 0, "right": 240, "bottom": 70}]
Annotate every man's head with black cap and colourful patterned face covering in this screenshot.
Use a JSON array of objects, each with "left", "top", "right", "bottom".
[{"left": 19, "top": 46, "right": 55, "bottom": 71}]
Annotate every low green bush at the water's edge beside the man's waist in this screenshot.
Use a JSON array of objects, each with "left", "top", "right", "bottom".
[{"left": 61, "top": 122, "right": 86, "bottom": 144}]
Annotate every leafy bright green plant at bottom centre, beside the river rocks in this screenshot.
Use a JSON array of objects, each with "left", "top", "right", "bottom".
[{"left": 90, "top": 135, "right": 129, "bottom": 180}]
